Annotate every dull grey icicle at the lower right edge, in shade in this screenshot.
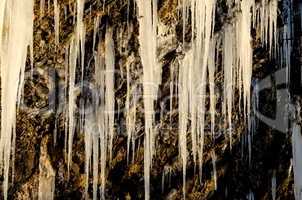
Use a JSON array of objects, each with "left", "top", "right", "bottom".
[{"left": 292, "top": 124, "right": 302, "bottom": 200}]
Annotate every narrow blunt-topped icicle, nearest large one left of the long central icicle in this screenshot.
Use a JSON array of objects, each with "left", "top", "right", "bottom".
[{"left": 105, "top": 28, "right": 115, "bottom": 160}]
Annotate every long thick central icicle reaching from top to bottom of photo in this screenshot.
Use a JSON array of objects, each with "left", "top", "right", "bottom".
[{"left": 136, "top": 0, "right": 161, "bottom": 200}]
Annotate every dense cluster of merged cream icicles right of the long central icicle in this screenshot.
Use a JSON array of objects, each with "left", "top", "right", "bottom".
[{"left": 178, "top": 0, "right": 216, "bottom": 198}]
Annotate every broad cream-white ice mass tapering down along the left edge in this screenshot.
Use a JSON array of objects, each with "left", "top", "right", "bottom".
[{"left": 0, "top": 0, "right": 34, "bottom": 199}]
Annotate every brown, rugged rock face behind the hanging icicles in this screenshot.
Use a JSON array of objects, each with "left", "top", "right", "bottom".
[{"left": 0, "top": 0, "right": 294, "bottom": 200}]
